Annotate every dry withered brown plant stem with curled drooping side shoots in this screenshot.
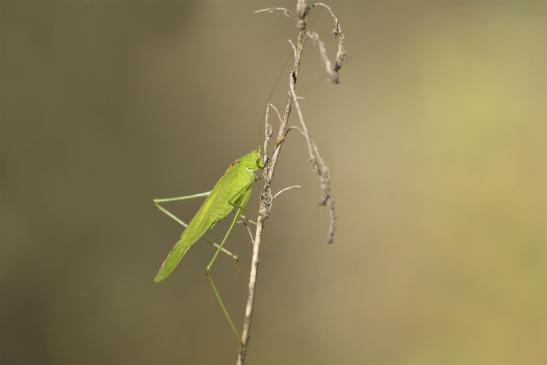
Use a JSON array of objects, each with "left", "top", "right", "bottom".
[{"left": 237, "top": 0, "right": 345, "bottom": 365}]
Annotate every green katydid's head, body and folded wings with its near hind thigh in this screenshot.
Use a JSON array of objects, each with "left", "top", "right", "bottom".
[{"left": 154, "top": 150, "right": 264, "bottom": 283}]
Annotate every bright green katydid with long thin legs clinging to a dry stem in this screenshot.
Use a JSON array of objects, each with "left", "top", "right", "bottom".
[{"left": 154, "top": 149, "right": 264, "bottom": 338}]
